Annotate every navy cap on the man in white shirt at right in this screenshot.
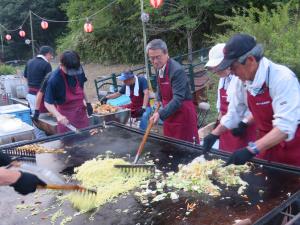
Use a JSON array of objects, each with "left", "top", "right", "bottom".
[{"left": 217, "top": 34, "right": 256, "bottom": 71}]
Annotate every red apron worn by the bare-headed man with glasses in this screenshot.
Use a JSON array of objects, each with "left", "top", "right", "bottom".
[{"left": 158, "top": 61, "right": 199, "bottom": 143}]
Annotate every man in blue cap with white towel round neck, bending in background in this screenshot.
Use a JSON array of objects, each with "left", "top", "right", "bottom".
[{"left": 102, "top": 71, "right": 151, "bottom": 130}]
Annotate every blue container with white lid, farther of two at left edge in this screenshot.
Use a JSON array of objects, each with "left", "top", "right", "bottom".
[{"left": 0, "top": 104, "right": 32, "bottom": 125}]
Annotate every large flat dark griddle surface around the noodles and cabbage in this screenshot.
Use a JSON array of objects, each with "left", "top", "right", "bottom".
[{"left": 0, "top": 122, "right": 300, "bottom": 225}]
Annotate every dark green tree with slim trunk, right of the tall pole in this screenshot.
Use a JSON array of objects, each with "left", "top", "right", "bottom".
[{"left": 144, "top": 0, "right": 284, "bottom": 61}]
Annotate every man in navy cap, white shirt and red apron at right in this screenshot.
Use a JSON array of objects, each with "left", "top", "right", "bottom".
[{"left": 213, "top": 34, "right": 300, "bottom": 166}]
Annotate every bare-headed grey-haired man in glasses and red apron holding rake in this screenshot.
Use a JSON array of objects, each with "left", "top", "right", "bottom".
[{"left": 147, "top": 39, "right": 199, "bottom": 143}]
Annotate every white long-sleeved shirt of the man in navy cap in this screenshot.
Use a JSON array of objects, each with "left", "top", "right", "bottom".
[{"left": 221, "top": 58, "right": 300, "bottom": 141}]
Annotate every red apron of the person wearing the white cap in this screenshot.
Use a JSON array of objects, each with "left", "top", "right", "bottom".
[{"left": 219, "top": 79, "right": 256, "bottom": 152}]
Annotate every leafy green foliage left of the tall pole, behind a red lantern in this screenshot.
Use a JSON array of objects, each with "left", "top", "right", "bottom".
[{"left": 58, "top": 0, "right": 143, "bottom": 63}]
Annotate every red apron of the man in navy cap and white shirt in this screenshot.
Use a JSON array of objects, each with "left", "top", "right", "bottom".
[{"left": 247, "top": 73, "right": 300, "bottom": 166}]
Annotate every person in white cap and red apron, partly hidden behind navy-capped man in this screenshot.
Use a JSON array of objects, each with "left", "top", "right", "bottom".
[{"left": 203, "top": 43, "right": 256, "bottom": 152}]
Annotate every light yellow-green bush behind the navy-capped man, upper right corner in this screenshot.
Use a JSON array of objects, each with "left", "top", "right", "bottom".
[{"left": 213, "top": 2, "right": 300, "bottom": 76}]
